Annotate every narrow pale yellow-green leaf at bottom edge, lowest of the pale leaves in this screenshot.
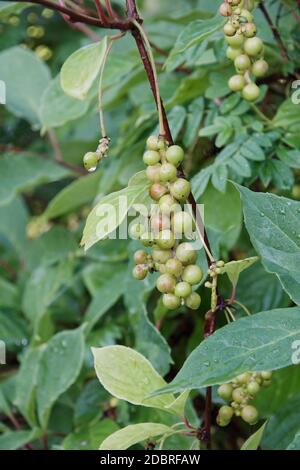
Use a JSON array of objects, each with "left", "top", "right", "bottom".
[{"left": 99, "top": 423, "right": 175, "bottom": 450}]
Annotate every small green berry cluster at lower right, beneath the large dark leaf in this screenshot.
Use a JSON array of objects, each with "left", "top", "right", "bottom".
[{"left": 217, "top": 371, "right": 272, "bottom": 426}]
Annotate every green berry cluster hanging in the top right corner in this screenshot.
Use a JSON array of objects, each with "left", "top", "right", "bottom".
[{"left": 220, "top": 0, "right": 269, "bottom": 101}]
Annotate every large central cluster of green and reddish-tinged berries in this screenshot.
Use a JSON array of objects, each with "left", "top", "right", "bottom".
[{"left": 130, "top": 136, "right": 203, "bottom": 310}]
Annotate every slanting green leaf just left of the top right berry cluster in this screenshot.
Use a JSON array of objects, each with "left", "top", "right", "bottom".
[{"left": 166, "top": 15, "right": 224, "bottom": 65}]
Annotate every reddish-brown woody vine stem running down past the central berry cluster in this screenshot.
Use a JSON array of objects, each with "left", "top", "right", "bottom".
[{"left": 14, "top": 0, "right": 226, "bottom": 448}]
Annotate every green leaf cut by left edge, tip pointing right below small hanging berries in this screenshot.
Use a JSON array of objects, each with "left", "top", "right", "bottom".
[{"left": 0, "top": 153, "right": 70, "bottom": 206}]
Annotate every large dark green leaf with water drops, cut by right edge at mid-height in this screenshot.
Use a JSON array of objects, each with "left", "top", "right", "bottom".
[{"left": 237, "top": 186, "right": 300, "bottom": 304}]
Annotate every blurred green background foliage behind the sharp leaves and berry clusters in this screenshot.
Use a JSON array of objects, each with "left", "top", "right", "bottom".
[{"left": 0, "top": 0, "right": 300, "bottom": 450}]
